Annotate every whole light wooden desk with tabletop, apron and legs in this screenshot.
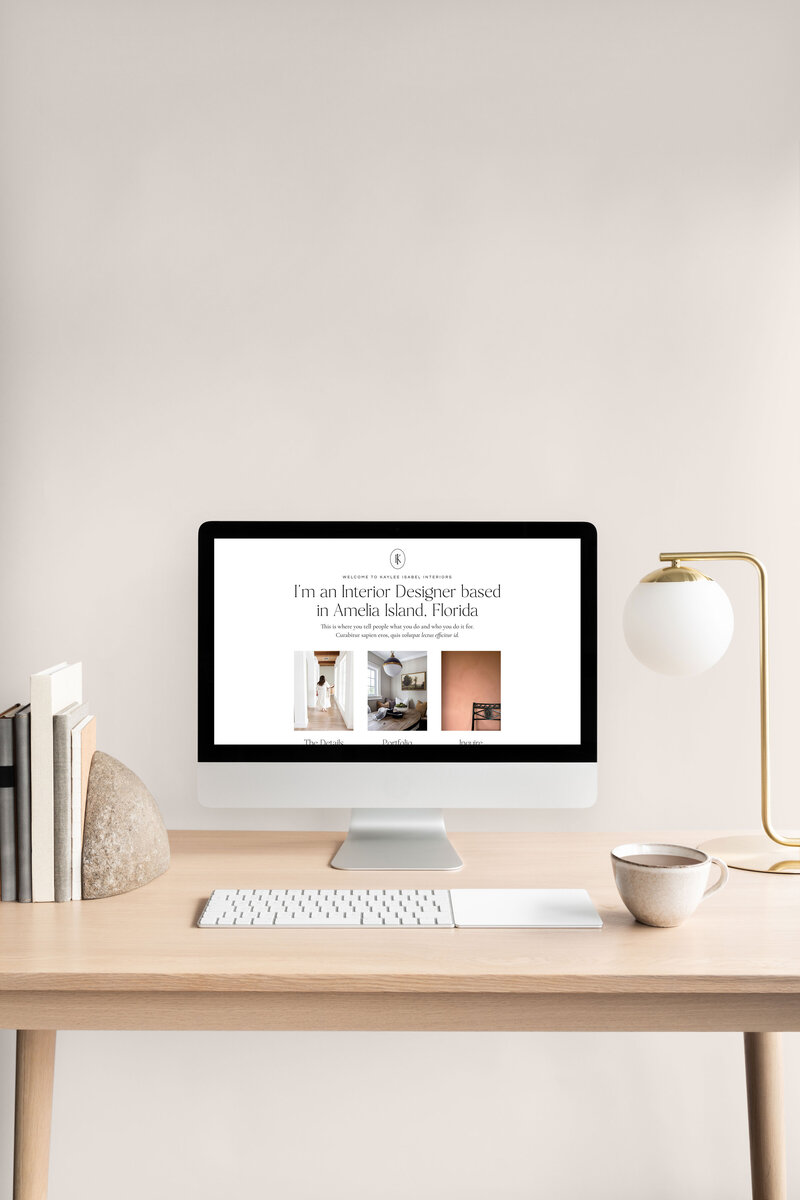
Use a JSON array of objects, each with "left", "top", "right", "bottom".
[{"left": 0, "top": 830, "right": 800, "bottom": 1200}]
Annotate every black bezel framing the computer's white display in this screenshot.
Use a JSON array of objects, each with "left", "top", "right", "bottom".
[{"left": 197, "top": 521, "right": 597, "bottom": 763}]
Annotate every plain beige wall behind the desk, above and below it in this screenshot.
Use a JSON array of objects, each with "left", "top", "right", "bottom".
[{"left": 0, "top": 0, "right": 800, "bottom": 1200}]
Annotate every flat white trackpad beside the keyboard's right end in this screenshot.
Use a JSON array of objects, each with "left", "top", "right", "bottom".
[{"left": 450, "top": 888, "right": 603, "bottom": 929}]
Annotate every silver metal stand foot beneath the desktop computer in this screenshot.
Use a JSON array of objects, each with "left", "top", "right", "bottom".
[{"left": 331, "top": 809, "right": 464, "bottom": 871}]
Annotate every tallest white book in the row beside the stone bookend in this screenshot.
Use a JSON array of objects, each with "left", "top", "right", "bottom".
[{"left": 30, "top": 662, "right": 83, "bottom": 900}]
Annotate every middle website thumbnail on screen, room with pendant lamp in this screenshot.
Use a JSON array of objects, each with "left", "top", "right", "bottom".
[{"left": 367, "top": 650, "right": 428, "bottom": 733}]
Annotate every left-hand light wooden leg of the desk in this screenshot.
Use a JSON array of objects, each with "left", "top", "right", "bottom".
[{"left": 14, "top": 1030, "right": 55, "bottom": 1200}]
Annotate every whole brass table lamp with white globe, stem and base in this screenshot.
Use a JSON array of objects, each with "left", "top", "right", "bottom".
[{"left": 622, "top": 550, "right": 800, "bottom": 875}]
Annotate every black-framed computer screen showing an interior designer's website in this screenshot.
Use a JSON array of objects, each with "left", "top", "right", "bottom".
[{"left": 198, "top": 522, "right": 596, "bottom": 763}]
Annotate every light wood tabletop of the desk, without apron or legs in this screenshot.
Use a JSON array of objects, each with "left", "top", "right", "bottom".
[{"left": 0, "top": 830, "right": 800, "bottom": 1000}]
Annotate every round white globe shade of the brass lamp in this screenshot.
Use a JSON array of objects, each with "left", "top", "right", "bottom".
[{"left": 622, "top": 566, "right": 733, "bottom": 676}]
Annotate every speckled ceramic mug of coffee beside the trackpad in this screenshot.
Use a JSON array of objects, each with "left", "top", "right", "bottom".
[{"left": 612, "top": 841, "right": 728, "bottom": 929}]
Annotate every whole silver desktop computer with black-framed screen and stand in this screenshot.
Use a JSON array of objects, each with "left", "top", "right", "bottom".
[{"left": 198, "top": 521, "right": 597, "bottom": 870}]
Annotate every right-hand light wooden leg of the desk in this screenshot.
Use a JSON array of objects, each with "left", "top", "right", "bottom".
[{"left": 745, "top": 1033, "right": 786, "bottom": 1200}]
